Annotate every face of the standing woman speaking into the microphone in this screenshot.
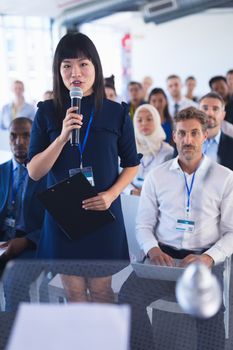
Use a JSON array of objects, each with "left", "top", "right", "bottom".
[{"left": 60, "top": 58, "right": 95, "bottom": 96}]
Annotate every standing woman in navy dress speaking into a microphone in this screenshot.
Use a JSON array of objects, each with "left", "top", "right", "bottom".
[{"left": 28, "top": 33, "right": 140, "bottom": 259}]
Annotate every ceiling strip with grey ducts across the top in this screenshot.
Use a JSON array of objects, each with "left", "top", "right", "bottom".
[{"left": 0, "top": 0, "right": 233, "bottom": 24}]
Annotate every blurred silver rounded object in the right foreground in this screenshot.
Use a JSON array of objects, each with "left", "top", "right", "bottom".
[{"left": 176, "top": 262, "right": 222, "bottom": 318}]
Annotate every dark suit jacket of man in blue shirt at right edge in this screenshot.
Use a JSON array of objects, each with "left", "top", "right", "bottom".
[{"left": 218, "top": 132, "right": 233, "bottom": 170}]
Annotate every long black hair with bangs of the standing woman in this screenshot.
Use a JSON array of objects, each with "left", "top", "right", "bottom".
[{"left": 53, "top": 33, "right": 104, "bottom": 119}]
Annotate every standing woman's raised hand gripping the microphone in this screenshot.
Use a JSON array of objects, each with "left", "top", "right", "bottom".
[{"left": 59, "top": 107, "right": 83, "bottom": 143}]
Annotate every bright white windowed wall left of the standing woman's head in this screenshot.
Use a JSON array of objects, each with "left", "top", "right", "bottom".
[{"left": 0, "top": 15, "right": 52, "bottom": 108}]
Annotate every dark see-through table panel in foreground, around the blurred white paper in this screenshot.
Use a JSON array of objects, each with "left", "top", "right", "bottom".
[{"left": 0, "top": 260, "right": 233, "bottom": 350}]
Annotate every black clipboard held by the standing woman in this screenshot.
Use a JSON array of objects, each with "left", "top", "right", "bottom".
[{"left": 38, "top": 172, "right": 115, "bottom": 240}]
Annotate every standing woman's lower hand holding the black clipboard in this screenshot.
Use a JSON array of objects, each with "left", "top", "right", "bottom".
[{"left": 83, "top": 191, "right": 116, "bottom": 210}]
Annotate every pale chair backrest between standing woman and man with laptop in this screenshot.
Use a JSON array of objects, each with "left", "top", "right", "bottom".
[{"left": 121, "top": 194, "right": 144, "bottom": 261}]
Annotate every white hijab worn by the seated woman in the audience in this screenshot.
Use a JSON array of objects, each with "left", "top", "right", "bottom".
[{"left": 133, "top": 104, "right": 166, "bottom": 156}]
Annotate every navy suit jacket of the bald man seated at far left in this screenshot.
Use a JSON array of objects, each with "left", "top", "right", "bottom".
[{"left": 0, "top": 160, "right": 46, "bottom": 245}]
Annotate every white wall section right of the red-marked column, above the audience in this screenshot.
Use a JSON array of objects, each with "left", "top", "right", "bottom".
[{"left": 132, "top": 11, "right": 233, "bottom": 95}]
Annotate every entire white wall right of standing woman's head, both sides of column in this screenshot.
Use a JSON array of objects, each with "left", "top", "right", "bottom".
[{"left": 81, "top": 9, "right": 233, "bottom": 95}]
